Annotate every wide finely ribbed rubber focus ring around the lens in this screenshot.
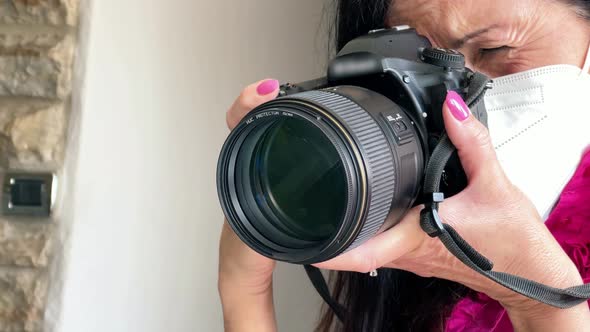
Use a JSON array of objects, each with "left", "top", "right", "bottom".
[{"left": 292, "top": 90, "right": 396, "bottom": 250}]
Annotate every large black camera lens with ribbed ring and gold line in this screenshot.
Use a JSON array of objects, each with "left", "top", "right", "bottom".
[{"left": 217, "top": 86, "right": 425, "bottom": 264}]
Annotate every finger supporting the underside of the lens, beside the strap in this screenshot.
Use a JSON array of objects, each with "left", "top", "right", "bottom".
[{"left": 314, "top": 207, "right": 426, "bottom": 273}]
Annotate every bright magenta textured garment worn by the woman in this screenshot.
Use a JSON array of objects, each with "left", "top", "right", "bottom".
[{"left": 445, "top": 150, "right": 590, "bottom": 332}]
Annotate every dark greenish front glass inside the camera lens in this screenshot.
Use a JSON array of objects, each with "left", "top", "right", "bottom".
[{"left": 252, "top": 118, "right": 347, "bottom": 241}]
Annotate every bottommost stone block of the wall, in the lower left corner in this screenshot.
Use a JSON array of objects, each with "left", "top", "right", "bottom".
[{"left": 0, "top": 269, "right": 47, "bottom": 332}]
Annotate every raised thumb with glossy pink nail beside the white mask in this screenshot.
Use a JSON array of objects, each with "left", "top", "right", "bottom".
[{"left": 443, "top": 91, "right": 499, "bottom": 180}]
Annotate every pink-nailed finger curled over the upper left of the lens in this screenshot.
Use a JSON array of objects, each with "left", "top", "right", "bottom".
[{"left": 226, "top": 79, "right": 279, "bottom": 129}]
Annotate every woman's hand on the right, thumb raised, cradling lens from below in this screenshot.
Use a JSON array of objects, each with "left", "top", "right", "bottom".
[{"left": 317, "top": 92, "right": 590, "bottom": 331}]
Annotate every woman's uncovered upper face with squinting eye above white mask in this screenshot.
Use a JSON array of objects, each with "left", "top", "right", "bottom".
[{"left": 387, "top": 0, "right": 590, "bottom": 77}]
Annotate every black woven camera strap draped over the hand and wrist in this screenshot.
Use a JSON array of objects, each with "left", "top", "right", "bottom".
[{"left": 305, "top": 73, "right": 590, "bottom": 321}]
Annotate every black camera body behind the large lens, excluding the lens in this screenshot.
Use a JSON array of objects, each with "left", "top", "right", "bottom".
[{"left": 279, "top": 26, "right": 487, "bottom": 204}]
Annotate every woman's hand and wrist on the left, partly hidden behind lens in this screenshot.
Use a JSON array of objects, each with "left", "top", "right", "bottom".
[{"left": 218, "top": 80, "right": 279, "bottom": 332}]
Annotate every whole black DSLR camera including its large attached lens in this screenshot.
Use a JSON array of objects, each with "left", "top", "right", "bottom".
[{"left": 217, "top": 27, "right": 487, "bottom": 264}]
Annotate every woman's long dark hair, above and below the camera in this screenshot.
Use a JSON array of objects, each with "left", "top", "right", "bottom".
[{"left": 316, "top": 0, "right": 590, "bottom": 332}]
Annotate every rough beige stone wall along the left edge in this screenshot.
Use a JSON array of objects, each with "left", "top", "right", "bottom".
[{"left": 0, "top": 0, "right": 78, "bottom": 332}]
